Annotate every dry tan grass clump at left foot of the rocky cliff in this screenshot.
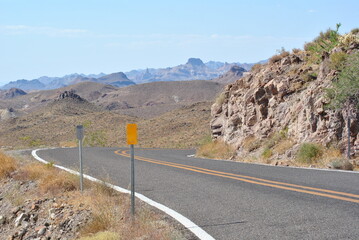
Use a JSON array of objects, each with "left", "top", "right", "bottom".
[{"left": 196, "top": 140, "right": 235, "bottom": 159}]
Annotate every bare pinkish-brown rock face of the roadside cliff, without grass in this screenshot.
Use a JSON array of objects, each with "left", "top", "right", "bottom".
[{"left": 211, "top": 46, "right": 359, "bottom": 159}]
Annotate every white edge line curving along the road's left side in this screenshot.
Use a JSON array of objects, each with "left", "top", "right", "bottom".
[{"left": 31, "top": 148, "right": 215, "bottom": 240}]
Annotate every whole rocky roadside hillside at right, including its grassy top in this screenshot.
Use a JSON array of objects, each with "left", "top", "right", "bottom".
[{"left": 211, "top": 31, "right": 359, "bottom": 162}]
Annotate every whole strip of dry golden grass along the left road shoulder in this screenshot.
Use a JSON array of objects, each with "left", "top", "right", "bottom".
[{"left": 0, "top": 153, "right": 185, "bottom": 240}]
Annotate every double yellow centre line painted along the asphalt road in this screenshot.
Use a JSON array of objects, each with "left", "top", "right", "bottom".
[{"left": 115, "top": 150, "right": 359, "bottom": 203}]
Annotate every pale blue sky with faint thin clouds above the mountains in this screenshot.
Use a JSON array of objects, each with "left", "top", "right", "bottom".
[{"left": 0, "top": 0, "right": 359, "bottom": 84}]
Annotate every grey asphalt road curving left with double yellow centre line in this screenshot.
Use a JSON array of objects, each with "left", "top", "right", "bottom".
[{"left": 38, "top": 148, "right": 359, "bottom": 240}]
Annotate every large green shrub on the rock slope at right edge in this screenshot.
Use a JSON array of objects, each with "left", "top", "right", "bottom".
[{"left": 325, "top": 52, "right": 359, "bottom": 109}]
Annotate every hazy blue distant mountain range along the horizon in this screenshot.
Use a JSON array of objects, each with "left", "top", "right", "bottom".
[{"left": 0, "top": 58, "right": 263, "bottom": 91}]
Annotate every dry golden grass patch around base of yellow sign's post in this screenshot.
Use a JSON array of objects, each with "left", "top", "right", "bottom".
[{"left": 76, "top": 184, "right": 181, "bottom": 240}]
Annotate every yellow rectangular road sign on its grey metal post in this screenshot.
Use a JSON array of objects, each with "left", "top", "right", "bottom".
[{"left": 126, "top": 124, "right": 137, "bottom": 216}]
